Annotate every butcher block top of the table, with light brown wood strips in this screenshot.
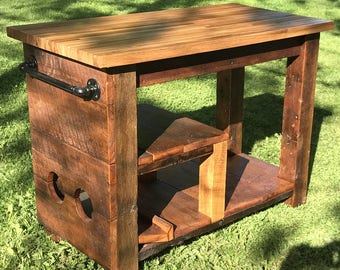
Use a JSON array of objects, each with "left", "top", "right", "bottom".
[{"left": 7, "top": 4, "right": 334, "bottom": 68}]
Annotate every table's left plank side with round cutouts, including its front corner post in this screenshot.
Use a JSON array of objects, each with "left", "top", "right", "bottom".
[{"left": 25, "top": 42, "right": 138, "bottom": 269}]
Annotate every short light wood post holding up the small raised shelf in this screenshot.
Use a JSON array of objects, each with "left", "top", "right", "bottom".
[{"left": 198, "top": 141, "right": 227, "bottom": 222}]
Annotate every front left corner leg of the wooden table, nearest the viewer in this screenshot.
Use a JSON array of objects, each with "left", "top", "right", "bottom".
[{"left": 108, "top": 71, "right": 138, "bottom": 270}]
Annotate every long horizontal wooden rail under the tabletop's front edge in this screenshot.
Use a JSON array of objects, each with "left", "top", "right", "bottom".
[{"left": 137, "top": 37, "right": 303, "bottom": 86}]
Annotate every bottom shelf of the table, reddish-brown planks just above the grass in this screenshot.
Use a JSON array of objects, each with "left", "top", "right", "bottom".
[{"left": 138, "top": 154, "right": 293, "bottom": 260}]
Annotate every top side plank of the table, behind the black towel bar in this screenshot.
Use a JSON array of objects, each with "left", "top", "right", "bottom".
[{"left": 24, "top": 46, "right": 113, "bottom": 162}]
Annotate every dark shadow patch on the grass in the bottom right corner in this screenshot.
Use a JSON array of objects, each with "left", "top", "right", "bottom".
[{"left": 280, "top": 241, "right": 340, "bottom": 270}]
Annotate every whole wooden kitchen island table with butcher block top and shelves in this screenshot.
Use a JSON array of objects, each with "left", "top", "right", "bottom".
[{"left": 7, "top": 4, "right": 334, "bottom": 270}]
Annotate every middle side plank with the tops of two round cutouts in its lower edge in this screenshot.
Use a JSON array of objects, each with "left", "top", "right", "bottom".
[{"left": 31, "top": 128, "right": 113, "bottom": 219}]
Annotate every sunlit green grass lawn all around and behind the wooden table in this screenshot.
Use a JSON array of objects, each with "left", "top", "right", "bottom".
[{"left": 0, "top": 0, "right": 340, "bottom": 270}]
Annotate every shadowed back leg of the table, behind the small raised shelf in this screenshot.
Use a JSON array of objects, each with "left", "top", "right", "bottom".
[{"left": 216, "top": 67, "right": 244, "bottom": 154}]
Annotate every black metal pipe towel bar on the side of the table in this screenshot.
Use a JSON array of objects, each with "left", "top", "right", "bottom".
[{"left": 19, "top": 56, "right": 100, "bottom": 100}]
